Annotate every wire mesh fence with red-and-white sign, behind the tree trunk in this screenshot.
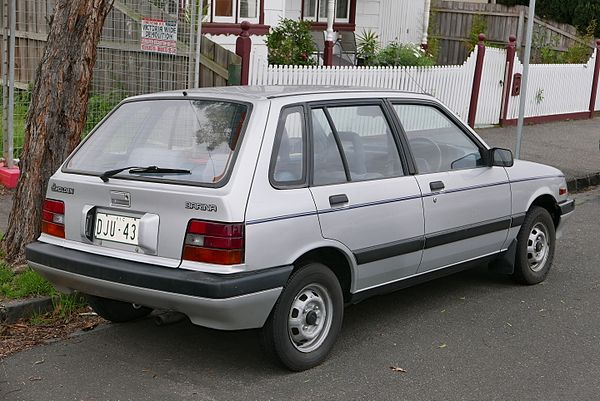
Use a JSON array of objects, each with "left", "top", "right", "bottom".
[{"left": 0, "top": 0, "right": 235, "bottom": 159}]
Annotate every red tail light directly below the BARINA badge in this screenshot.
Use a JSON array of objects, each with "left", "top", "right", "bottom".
[{"left": 183, "top": 220, "right": 244, "bottom": 265}]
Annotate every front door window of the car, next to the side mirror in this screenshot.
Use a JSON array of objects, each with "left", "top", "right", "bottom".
[{"left": 394, "top": 104, "right": 485, "bottom": 174}]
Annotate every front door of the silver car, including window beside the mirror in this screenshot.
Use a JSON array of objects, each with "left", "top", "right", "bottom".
[{"left": 393, "top": 103, "right": 511, "bottom": 272}]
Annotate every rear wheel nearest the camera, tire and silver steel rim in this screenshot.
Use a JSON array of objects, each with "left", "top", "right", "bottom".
[{"left": 261, "top": 263, "right": 344, "bottom": 372}]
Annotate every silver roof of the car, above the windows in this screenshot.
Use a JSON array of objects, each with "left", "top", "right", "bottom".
[{"left": 127, "top": 85, "right": 431, "bottom": 100}]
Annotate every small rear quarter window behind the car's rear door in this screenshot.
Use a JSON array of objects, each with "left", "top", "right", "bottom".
[{"left": 271, "top": 107, "right": 306, "bottom": 185}]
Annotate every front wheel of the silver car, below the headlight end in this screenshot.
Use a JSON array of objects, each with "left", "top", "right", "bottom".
[{"left": 513, "top": 206, "right": 556, "bottom": 285}]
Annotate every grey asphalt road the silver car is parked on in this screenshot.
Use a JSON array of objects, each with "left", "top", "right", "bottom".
[{"left": 0, "top": 189, "right": 600, "bottom": 401}]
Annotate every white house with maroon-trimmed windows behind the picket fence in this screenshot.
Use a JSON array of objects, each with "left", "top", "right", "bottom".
[{"left": 202, "top": 0, "right": 431, "bottom": 63}]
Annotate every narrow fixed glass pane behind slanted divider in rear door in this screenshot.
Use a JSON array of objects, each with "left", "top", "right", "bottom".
[{"left": 312, "top": 109, "right": 348, "bottom": 185}]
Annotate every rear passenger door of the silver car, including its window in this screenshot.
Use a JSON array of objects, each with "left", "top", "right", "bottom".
[{"left": 309, "top": 101, "right": 424, "bottom": 291}]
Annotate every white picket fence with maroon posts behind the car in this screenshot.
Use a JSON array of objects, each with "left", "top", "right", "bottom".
[{"left": 249, "top": 48, "right": 600, "bottom": 127}]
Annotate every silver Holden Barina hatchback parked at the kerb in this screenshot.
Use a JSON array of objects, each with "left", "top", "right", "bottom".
[{"left": 27, "top": 86, "right": 574, "bottom": 370}]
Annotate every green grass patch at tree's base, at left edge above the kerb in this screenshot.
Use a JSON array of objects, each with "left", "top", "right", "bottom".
[{"left": 0, "top": 262, "right": 55, "bottom": 299}]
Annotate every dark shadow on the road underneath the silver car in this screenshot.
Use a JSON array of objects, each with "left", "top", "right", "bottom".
[{"left": 90, "top": 267, "right": 514, "bottom": 374}]
